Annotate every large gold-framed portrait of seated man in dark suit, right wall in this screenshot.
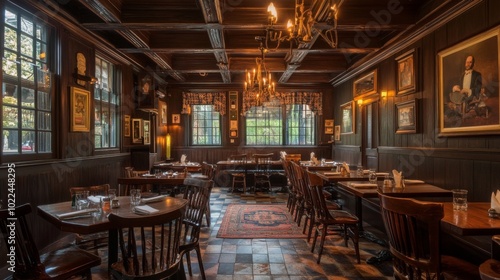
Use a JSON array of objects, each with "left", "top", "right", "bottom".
[{"left": 438, "top": 27, "right": 500, "bottom": 136}]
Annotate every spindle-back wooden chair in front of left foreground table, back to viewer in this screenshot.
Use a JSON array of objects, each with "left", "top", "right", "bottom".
[{"left": 108, "top": 203, "right": 185, "bottom": 280}]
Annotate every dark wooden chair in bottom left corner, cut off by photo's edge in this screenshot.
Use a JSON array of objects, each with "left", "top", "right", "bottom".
[{"left": 0, "top": 204, "right": 101, "bottom": 279}]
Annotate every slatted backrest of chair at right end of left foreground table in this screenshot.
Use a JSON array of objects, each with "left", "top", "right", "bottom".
[{"left": 183, "top": 178, "right": 214, "bottom": 243}]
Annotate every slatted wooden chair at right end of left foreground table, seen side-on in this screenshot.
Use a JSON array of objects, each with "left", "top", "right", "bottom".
[{"left": 180, "top": 178, "right": 213, "bottom": 279}]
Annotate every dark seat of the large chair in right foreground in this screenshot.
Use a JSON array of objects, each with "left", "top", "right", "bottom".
[{"left": 441, "top": 255, "right": 481, "bottom": 280}]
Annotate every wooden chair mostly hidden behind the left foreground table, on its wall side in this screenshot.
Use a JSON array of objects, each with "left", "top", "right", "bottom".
[{"left": 69, "top": 184, "right": 110, "bottom": 254}]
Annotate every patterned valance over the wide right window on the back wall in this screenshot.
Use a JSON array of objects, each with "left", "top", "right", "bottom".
[{"left": 242, "top": 92, "right": 323, "bottom": 116}]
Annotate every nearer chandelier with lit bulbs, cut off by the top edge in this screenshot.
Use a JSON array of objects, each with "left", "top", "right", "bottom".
[{"left": 266, "top": 0, "right": 344, "bottom": 49}]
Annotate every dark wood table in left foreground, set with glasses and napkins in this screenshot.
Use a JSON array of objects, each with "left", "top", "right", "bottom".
[{"left": 37, "top": 196, "right": 187, "bottom": 267}]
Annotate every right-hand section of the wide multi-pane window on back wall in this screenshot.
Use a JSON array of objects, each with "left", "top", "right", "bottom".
[{"left": 286, "top": 104, "right": 316, "bottom": 146}]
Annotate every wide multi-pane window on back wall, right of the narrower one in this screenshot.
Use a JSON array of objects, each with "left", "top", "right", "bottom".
[{"left": 245, "top": 104, "right": 316, "bottom": 146}]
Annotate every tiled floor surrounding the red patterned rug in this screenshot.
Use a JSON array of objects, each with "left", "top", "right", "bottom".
[{"left": 93, "top": 188, "right": 393, "bottom": 280}]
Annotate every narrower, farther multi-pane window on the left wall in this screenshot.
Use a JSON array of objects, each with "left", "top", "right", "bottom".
[{"left": 94, "top": 57, "right": 120, "bottom": 149}]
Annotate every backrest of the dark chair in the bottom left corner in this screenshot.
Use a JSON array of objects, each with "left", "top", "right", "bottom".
[{"left": 0, "top": 204, "right": 45, "bottom": 279}]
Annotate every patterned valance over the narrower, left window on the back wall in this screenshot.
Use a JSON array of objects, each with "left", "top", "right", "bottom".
[{"left": 181, "top": 92, "right": 226, "bottom": 115}]
